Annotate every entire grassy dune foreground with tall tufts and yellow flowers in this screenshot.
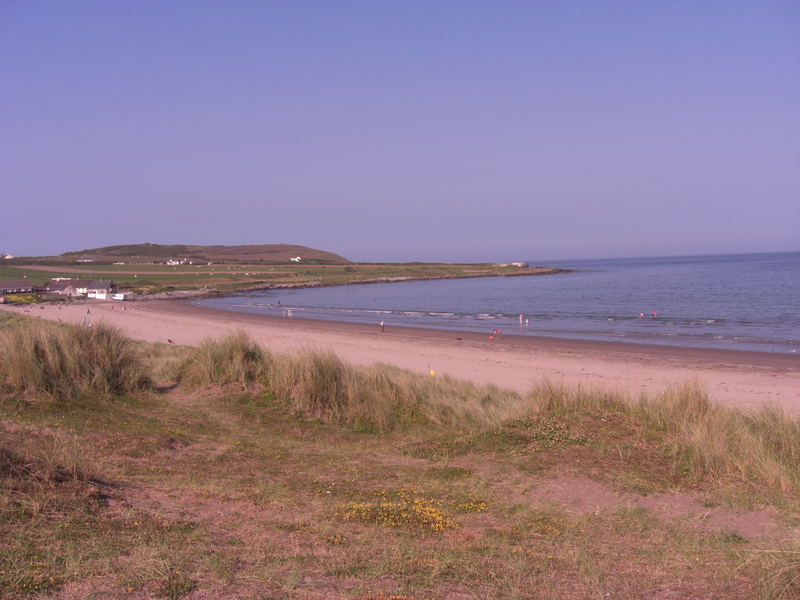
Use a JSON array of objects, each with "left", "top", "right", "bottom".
[{"left": 0, "top": 317, "right": 800, "bottom": 600}]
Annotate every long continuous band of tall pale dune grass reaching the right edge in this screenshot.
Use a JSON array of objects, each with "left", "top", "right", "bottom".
[{"left": 172, "top": 332, "right": 800, "bottom": 500}]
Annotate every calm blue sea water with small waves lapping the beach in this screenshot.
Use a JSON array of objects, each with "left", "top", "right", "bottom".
[{"left": 195, "top": 252, "right": 800, "bottom": 354}]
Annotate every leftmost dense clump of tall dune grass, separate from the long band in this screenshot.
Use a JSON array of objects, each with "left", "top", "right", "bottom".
[{"left": 0, "top": 320, "right": 150, "bottom": 401}]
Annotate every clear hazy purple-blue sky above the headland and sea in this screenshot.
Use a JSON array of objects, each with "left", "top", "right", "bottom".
[{"left": 0, "top": 0, "right": 800, "bottom": 261}]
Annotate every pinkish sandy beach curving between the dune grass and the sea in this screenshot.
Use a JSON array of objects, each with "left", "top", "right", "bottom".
[{"left": 7, "top": 300, "right": 800, "bottom": 414}]
